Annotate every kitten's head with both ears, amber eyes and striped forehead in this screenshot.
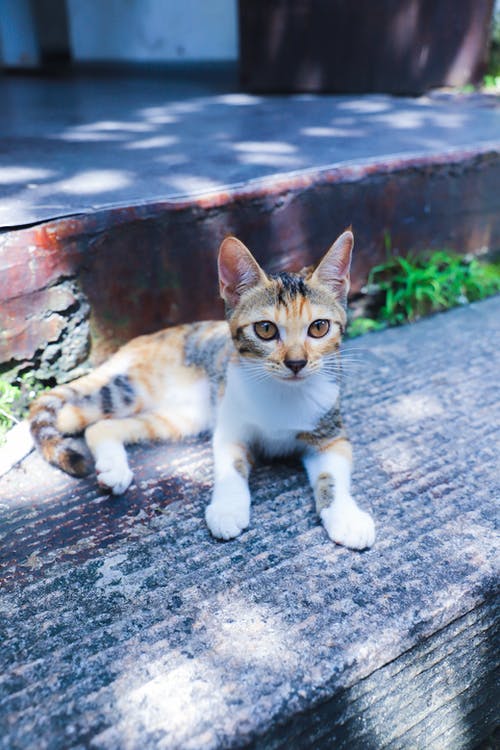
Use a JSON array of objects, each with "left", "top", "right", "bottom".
[{"left": 219, "top": 232, "right": 352, "bottom": 384}]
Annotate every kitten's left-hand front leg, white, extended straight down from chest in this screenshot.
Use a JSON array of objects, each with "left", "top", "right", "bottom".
[{"left": 205, "top": 430, "right": 251, "bottom": 539}]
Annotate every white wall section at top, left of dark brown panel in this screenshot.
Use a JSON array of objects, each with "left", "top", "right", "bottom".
[{"left": 67, "top": 0, "right": 238, "bottom": 62}]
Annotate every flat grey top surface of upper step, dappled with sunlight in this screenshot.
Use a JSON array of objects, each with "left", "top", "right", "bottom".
[{"left": 0, "top": 69, "right": 500, "bottom": 227}]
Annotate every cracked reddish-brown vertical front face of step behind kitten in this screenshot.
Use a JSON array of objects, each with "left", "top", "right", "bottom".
[{"left": 0, "top": 144, "right": 500, "bottom": 380}]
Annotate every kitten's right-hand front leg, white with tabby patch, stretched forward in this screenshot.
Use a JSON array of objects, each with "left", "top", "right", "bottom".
[{"left": 303, "top": 438, "right": 375, "bottom": 549}]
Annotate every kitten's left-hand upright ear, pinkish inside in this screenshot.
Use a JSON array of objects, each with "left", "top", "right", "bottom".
[{"left": 218, "top": 237, "right": 267, "bottom": 308}]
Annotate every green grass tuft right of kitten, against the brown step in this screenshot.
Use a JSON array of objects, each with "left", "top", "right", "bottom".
[{"left": 348, "top": 250, "right": 500, "bottom": 338}]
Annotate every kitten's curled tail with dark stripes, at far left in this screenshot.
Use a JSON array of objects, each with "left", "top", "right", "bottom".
[{"left": 29, "top": 385, "right": 93, "bottom": 477}]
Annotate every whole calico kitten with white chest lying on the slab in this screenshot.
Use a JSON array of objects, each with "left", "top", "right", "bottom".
[{"left": 30, "top": 231, "right": 375, "bottom": 549}]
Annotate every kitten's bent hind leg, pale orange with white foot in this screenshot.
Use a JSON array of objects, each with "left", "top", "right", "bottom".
[{"left": 85, "top": 413, "right": 181, "bottom": 495}]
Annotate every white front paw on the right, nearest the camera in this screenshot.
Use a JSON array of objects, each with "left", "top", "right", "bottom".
[{"left": 321, "top": 501, "right": 375, "bottom": 549}]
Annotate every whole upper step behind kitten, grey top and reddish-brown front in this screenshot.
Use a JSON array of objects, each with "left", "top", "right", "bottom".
[{"left": 0, "top": 70, "right": 500, "bottom": 379}]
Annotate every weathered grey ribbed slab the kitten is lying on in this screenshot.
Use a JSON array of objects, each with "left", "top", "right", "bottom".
[{"left": 0, "top": 298, "right": 500, "bottom": 750}]
